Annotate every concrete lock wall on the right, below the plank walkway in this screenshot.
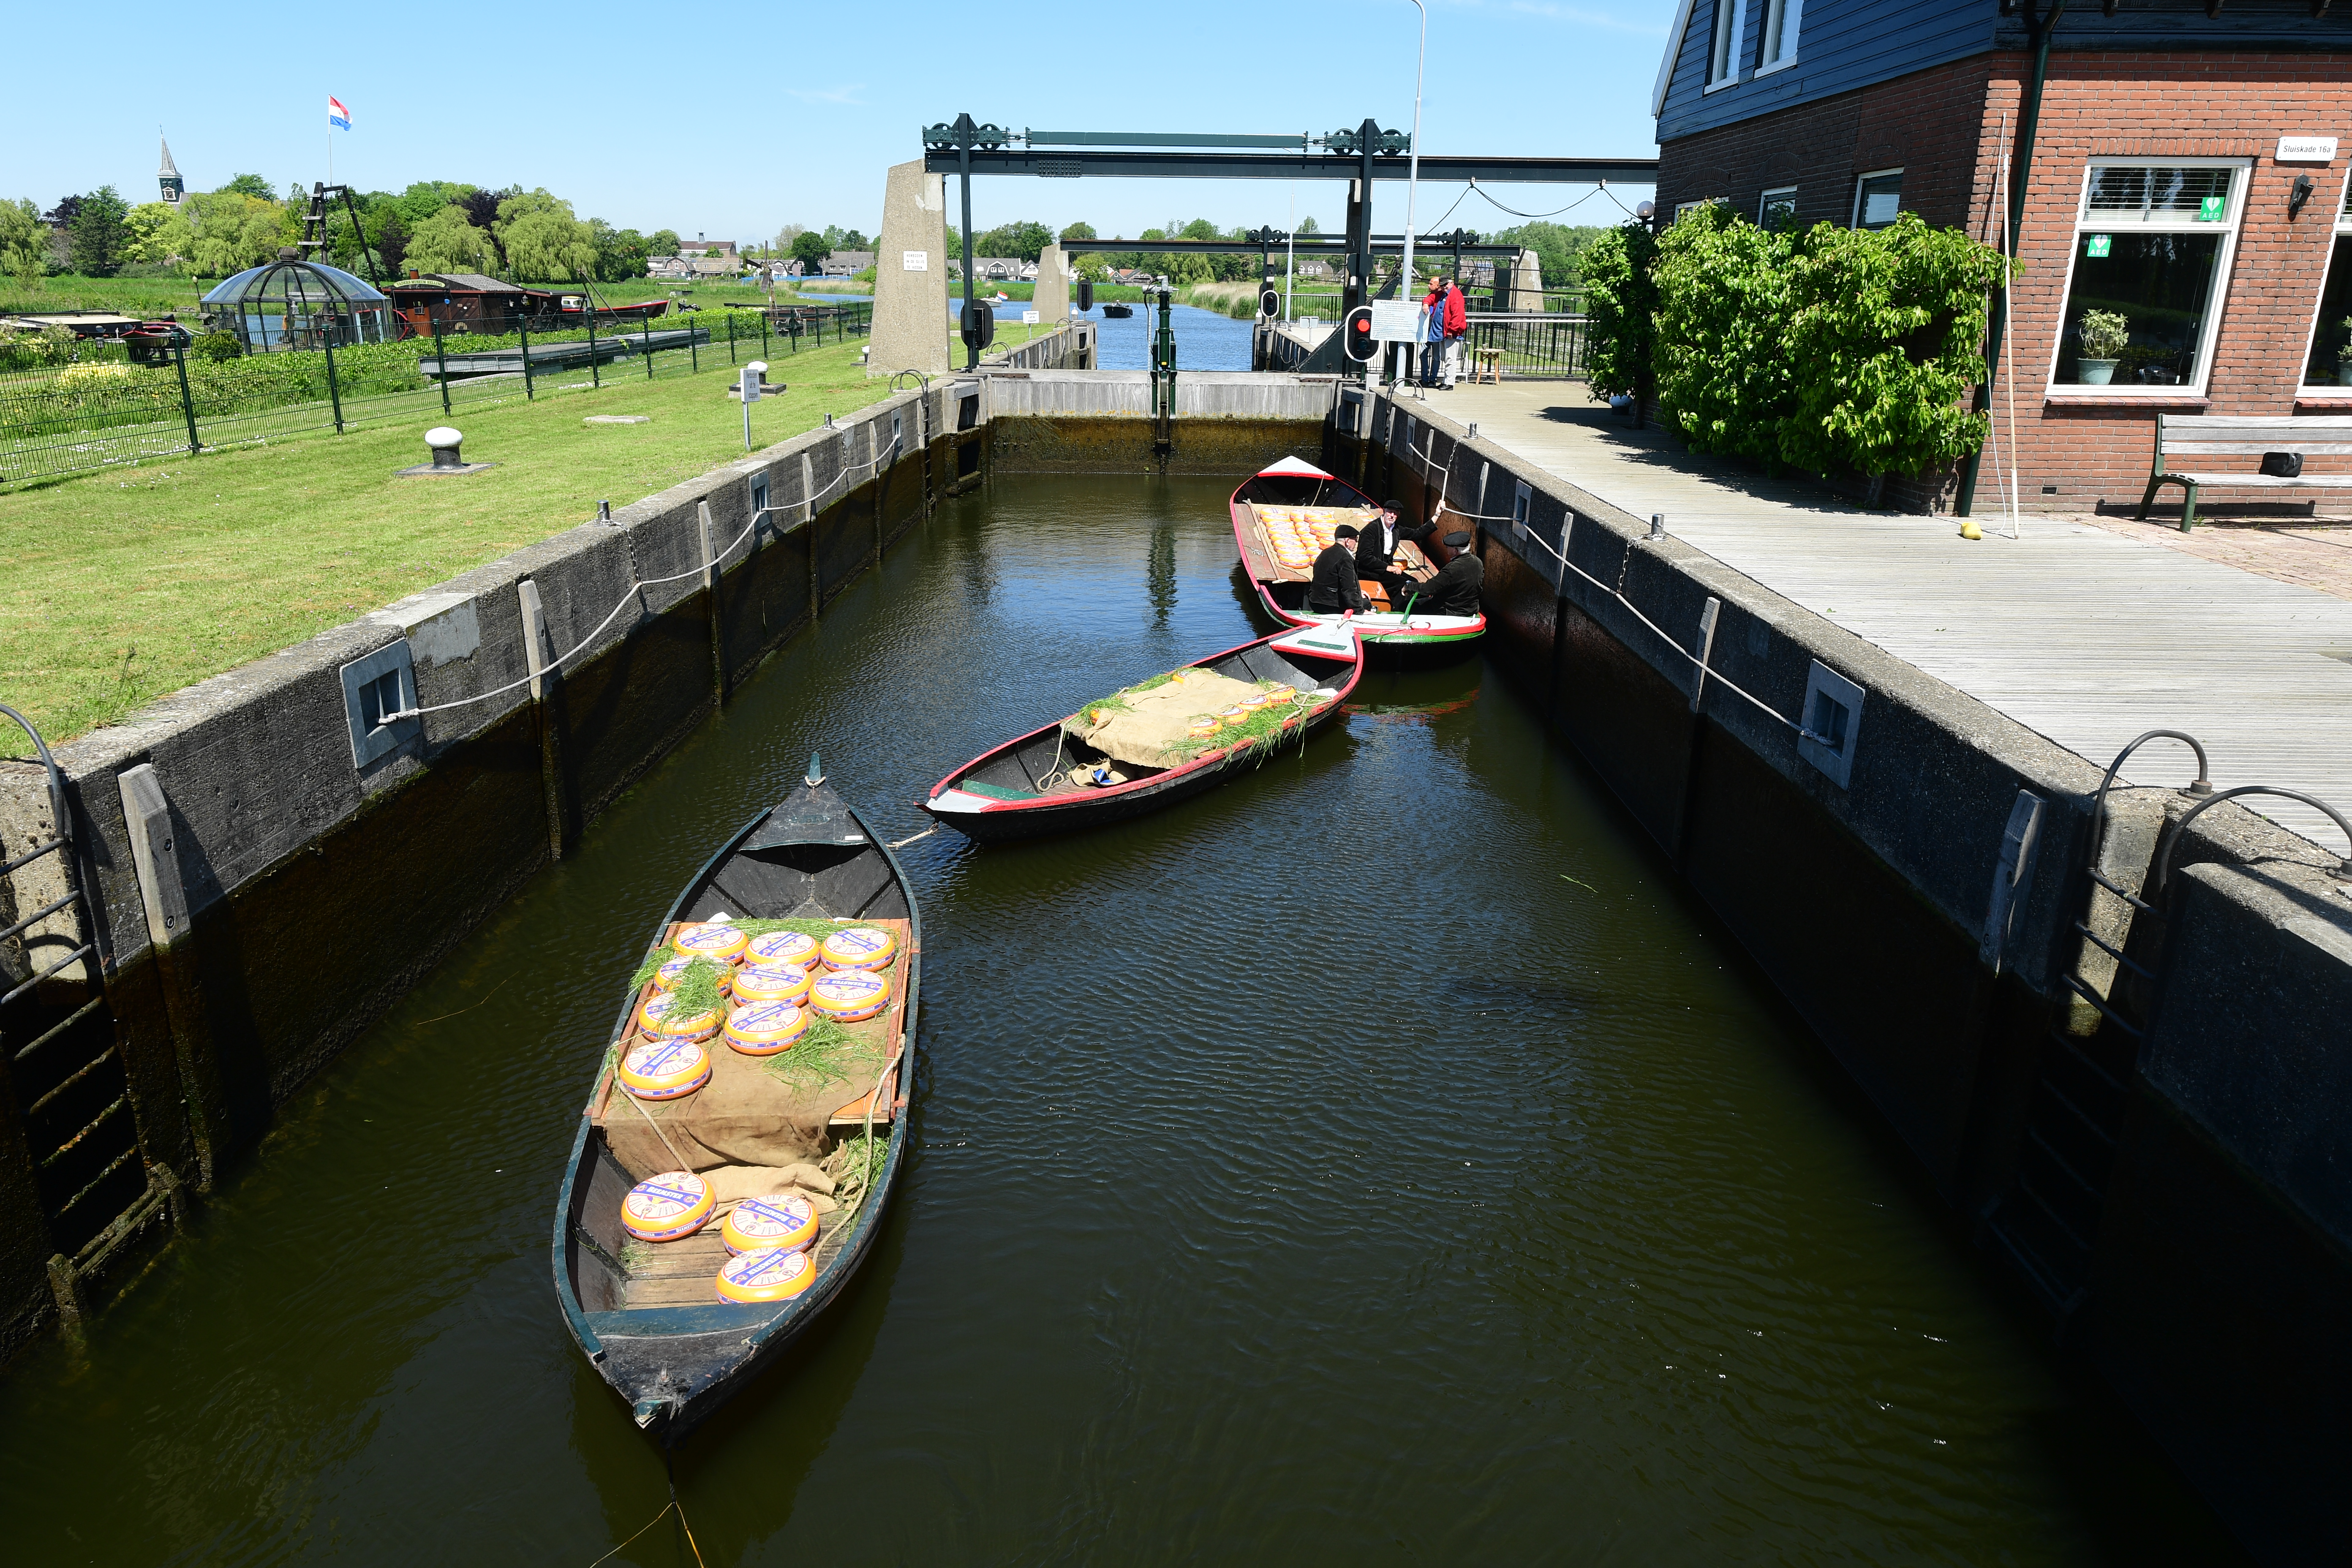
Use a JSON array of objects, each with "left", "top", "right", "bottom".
[{"left": 1329, "top": 395, "right": 2352, "bottom": 1563}]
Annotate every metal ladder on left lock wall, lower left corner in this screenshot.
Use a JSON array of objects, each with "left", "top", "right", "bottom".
[{"left": 0, "top": 705, "right": 186, "bottom": 1326}]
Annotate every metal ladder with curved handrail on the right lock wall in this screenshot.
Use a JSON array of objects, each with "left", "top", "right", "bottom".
[{"left": 1985, "top": 729, "right": 2213, "bottom": 1335}]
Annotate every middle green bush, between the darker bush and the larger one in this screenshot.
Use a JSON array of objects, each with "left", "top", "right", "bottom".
[{"left": 1651, "top": 202, "right": 1794, "bottom": 463}]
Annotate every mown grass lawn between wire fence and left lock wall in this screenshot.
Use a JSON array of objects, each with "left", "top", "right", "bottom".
[{"left": 0, "top": 336, "right": 898, "bottom": 740}]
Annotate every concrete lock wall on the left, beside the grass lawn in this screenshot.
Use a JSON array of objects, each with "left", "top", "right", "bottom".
[{"left": 0, "top": 324, "right": 1094, "bottom": 1354}]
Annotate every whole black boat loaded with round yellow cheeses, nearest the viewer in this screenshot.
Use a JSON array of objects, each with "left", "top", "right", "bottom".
[{"left": 555, "top": 760, "right": 922, "bottom": 1441}]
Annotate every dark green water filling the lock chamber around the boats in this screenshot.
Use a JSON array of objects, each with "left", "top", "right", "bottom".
[{"left": 0, "top": 479, "right": 2235, "bottom": 1568}]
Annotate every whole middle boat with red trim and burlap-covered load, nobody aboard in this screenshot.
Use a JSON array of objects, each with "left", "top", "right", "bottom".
[{"left": 922, "top": 625, "right": 1364, "bottom": 844}]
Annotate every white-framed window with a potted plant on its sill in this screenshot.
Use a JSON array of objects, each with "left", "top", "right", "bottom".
[{"left": 2051, "top": 160, "right": 2246, "bottom": 390}]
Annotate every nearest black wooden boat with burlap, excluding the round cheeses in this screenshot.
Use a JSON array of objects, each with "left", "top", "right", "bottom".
[{"left": 555, "top": 757, "right": 922, "bottom": 1443}]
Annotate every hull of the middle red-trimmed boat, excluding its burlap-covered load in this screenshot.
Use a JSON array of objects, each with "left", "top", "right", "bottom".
[{"left": 922, "top": 625, "right": 1364, "bottom": 844}]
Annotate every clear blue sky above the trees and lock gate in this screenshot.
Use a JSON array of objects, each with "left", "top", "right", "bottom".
[{"left": 14, "top": 0, "right": 1674, "bottom": 240}]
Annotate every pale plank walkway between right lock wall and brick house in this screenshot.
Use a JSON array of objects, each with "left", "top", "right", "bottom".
[{"left": 1439, "top": 381, "right": 2352, "bottom": 853}]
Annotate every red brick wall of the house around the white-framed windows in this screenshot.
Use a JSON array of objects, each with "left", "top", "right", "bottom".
[{"left": 1658, "top": 52, "right": 2352, "bottom": 512}]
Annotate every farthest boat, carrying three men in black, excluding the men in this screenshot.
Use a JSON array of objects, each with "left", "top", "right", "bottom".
[{"left": 1233, "top": 458, "right": 1486, "bottom": 661}]
